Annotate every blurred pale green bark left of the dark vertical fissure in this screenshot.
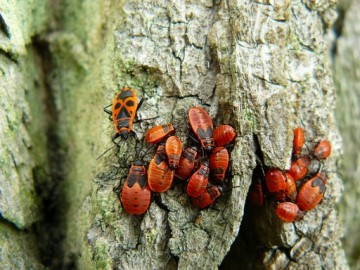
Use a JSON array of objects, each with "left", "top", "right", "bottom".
[{"left": 0, "top": 1, "right": 48, "bottom": 269}]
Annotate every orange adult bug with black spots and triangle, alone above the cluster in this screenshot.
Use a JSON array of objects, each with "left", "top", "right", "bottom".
[{"left": 104, "top": 86, "right": 138, "bottom": 144}]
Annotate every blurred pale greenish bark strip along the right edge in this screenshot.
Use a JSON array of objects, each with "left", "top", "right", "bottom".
[{"left": 334, "top": 1, "right": 360, "bottom": 269}]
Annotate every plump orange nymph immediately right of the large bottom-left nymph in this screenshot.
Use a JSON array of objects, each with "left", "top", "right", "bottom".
[{"left": 148, "top": 144, "right": 174, "bottom": 193}]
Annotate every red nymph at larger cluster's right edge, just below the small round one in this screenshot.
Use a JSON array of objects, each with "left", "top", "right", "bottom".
[{"left": 209, "top": 147, "right": 229, "bottom": 181}]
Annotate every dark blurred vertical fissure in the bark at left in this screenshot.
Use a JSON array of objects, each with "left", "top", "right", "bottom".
[{"left": 32, "top": 38, "right": 67, "bottom": 269}]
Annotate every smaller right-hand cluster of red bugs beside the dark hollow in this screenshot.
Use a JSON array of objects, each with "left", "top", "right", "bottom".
[{"left": 249, "top": 127, "right": 331, "bottom": 222}]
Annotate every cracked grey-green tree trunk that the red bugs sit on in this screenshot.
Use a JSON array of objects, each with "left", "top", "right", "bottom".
[{"left": 0, "top": 0, "right": 347, "bottom": 269}]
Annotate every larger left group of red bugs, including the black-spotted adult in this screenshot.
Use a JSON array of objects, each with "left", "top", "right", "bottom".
[{"left": 104, "top": 87, "right": 236, "bottom": 215}]
